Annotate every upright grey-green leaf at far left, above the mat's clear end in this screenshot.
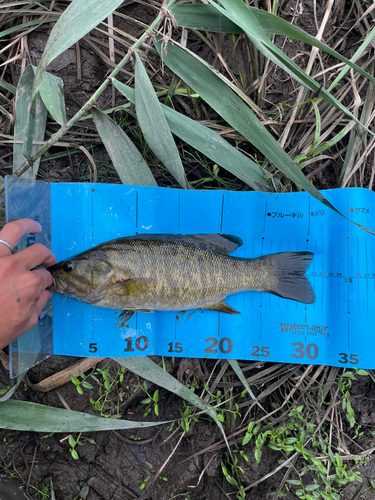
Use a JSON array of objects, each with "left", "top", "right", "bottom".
[{"left": 13, "top": 65, "right": 47, "bottom": 179}]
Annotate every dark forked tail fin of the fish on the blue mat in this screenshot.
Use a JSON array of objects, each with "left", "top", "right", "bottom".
[{"left": 261, "top": 252, "right": 315, "bottom": 304}]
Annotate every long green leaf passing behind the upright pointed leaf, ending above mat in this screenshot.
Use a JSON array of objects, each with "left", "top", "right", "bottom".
[{"left": 112, "top": 79, "right": 269, "bottom": 191}]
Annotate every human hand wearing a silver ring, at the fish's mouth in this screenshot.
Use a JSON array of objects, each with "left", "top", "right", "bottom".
[{"left": 0, "top": 219, "right": 56, "bottom": 349}]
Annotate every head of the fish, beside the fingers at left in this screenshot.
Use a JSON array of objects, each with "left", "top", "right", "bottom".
[{"left": 47, "top": 251, "right": 115, "bottom": 303}]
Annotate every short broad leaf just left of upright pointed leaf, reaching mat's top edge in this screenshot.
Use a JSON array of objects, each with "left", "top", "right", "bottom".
[{"left": 92, "top": 108, "right": 157, "bottom": 186}]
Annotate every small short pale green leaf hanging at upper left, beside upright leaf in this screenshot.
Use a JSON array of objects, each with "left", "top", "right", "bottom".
[{"left": 33, "top": 66, "right": 66, "bottom": 125}]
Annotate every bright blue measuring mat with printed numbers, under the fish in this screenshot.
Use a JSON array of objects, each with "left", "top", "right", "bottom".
[{"left": 4, "top": 178, "right": 375, "bottom": 368}]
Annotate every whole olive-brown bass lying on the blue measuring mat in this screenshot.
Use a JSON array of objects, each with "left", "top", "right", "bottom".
[{"left": 48, "top": 234, "right": 315, "bottom": 314}]
